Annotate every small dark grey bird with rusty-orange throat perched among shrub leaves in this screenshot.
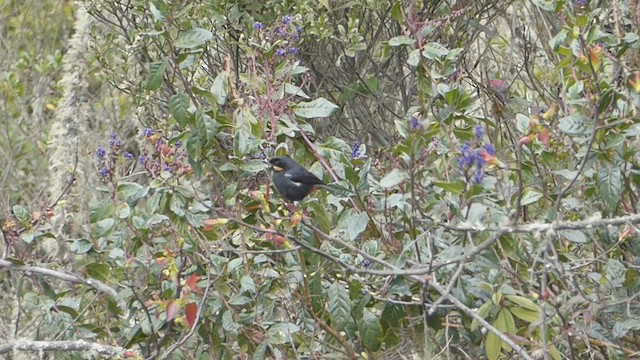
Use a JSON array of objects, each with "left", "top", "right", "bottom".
[{"left": 269, "top": 156, "right": 325, "bottom": 201}]
